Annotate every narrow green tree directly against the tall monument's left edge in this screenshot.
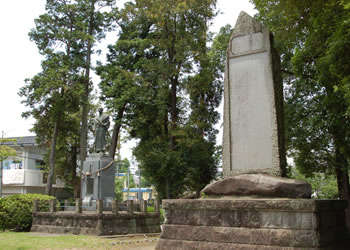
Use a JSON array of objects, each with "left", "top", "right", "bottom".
[{"left": 182, "top": 25, "right": 232, "bottom": 197}]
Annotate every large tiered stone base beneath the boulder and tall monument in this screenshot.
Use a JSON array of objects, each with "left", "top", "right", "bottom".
[{"left": 156, "top": 199, "right": 350, "bottom": 250}]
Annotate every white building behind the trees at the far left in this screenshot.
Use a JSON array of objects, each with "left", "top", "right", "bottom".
[{"left": 2, "top": 136, "right": 66, "bottom": 198}]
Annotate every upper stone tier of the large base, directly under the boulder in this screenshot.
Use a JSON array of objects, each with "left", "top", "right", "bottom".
[{"left": 164, "top": 200, "right": 346, "bottom": 230}]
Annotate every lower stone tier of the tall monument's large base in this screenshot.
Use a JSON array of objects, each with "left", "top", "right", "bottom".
[{"left": 161, "top": 225, "right": 347, "bottom": 248}]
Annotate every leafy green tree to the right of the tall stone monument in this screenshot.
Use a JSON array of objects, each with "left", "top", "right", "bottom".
[{"left": 253, "top": 0, "right": 350, "bottom": 211}]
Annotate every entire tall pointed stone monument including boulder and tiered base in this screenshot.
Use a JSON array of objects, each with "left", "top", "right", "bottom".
[{"left": 156, "top": 12, "right": 350, "bottom": 250}]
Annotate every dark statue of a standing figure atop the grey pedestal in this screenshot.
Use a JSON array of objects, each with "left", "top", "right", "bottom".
[{"left": 94, "top": 108, "right": 110, "bottom": 153}]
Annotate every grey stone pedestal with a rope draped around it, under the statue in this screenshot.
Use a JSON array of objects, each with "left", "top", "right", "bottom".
[{"left": 82, "top": 155, "right": 116, "bottom": 206}]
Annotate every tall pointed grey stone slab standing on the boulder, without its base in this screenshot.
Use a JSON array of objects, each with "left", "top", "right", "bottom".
[{"left": 223, "top": 12, "right": 286, "bottom": 177}]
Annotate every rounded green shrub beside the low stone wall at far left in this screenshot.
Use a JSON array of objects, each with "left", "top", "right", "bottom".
[{"left": 0, "top": 194, "right": 56, "bottom": 231}]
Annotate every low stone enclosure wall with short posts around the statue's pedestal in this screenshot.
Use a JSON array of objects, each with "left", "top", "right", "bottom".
[{"left": 31, "top": 199, "right": 160, "bottom": 235}]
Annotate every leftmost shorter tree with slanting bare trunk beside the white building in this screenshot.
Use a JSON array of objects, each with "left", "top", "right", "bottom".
[{"left": 20, "top": 54, "right": 79, "bottom": 194}]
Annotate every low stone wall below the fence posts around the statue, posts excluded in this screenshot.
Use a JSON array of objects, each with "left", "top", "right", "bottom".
[{"left": 31, "top": 212, "right": 160, "bottom": 235}]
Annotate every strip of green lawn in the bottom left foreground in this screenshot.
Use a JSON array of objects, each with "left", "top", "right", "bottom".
[{"left": 0, "top": 232, "right": 157, "bottom": 250}]
